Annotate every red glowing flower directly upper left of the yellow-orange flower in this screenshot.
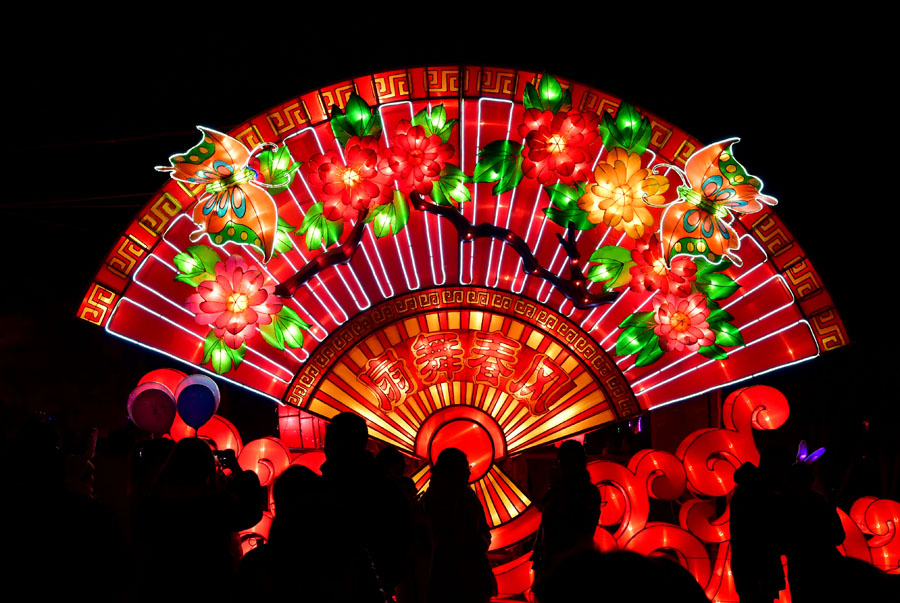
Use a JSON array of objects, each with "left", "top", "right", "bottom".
[{"left": 519, "top": 109, "right": 600, "bottom": 186}]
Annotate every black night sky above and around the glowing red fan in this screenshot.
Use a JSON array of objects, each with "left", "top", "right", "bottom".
[{"left": 0, "top": 21, "right": 898, "bottom": 498}]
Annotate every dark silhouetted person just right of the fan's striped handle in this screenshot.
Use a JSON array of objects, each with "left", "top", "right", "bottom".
[{"left": 532, "top": 440, "right": 602, "bottom": 579}]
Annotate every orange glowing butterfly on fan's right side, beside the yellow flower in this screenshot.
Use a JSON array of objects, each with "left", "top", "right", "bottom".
[{"left": 645, "top": 138, "right": 778, "bottom": 266}]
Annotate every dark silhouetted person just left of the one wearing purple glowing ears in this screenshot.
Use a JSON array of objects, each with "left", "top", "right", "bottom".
[{"left": 730, "top": 451, "right": 785, "bottom": 603}]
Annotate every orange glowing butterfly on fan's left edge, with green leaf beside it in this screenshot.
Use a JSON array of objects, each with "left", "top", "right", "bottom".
[{"left": 156, "top": 126, "right": 299, "bottom": 262}]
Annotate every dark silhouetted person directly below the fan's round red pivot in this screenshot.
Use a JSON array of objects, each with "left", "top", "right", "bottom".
[{"left": 422, "top": 448, "right": 497, "bottom": 603}]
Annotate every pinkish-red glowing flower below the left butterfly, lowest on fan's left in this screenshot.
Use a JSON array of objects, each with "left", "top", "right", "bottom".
[{"left": 185, "top": 255, "right": 282, "bottom": 349}]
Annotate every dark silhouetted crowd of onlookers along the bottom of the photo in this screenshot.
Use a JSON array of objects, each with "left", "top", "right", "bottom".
[{"left": 3, "top": 404, "right": 897, "bottom": 603}]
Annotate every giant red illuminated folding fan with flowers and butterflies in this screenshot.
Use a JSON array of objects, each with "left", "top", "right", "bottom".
[{"left": 79, "top": 66, "right": 847, "bottom": 592}]
